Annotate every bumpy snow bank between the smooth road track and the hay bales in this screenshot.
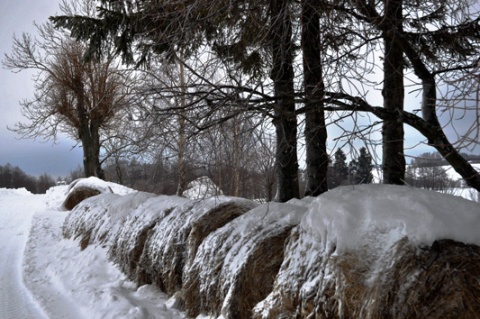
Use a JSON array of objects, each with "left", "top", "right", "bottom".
[{"left": 24, "top": 210, "right": 184, "bottom": 319}]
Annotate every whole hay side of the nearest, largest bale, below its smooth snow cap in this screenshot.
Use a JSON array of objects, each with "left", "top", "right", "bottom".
[{"left": 252, "top": 228, "right": 480, "bottom": 319}]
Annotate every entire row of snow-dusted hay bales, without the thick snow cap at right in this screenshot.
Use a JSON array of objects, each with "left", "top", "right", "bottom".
[{"left": 63, "top": 186, "right": 480, "bottom": 319}]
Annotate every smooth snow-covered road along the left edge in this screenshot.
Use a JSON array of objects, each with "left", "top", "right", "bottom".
[{"left": 0, "top": 194, "right": 45, "bottom": 319}]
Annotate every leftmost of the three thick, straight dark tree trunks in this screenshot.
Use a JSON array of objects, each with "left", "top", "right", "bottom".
[{"left": 270, "top": 0, "right": 300, "bottom": 202}]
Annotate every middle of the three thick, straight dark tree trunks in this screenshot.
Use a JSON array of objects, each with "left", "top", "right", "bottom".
[{"left": 302, "top": 0, "right": 329, "bottom": 196}]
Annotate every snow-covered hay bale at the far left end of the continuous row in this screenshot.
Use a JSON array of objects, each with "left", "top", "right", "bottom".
[{"left": 63, "top": 192, "right": 155, "bottom": 249}]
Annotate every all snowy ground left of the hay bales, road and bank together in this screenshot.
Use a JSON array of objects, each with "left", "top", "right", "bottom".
[{"left": 0, "top": 186, "right": 183, "bottom": 319}]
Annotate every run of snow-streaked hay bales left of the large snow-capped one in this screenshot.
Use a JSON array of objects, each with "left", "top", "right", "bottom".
[{"left": 63, "top": 192, "right": 306, "bottom": 318}]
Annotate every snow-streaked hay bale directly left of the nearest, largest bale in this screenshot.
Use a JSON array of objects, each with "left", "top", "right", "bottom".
[{"left": 183, "top": 203, "right": 307, "bottom": 318}]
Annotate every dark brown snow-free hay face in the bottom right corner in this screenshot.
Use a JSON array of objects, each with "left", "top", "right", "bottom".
[{"left": 362, "top": 240, "right": 480, "bottom": 319}]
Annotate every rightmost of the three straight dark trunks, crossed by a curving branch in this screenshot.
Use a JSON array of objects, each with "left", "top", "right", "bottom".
[{"left": 382, "top": 0, "right": 405, "bottom": 185}]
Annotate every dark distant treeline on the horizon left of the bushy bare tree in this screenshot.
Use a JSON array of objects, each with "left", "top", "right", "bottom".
[{"left": 0, "top": 164, "right": 56, "bottom": 194}]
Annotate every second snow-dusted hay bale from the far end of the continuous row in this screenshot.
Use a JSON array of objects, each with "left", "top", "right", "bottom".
[{"left": 109, "top": 196, "right": 189, "bottom": 285}]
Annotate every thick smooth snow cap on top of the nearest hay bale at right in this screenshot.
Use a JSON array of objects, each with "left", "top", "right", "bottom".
[{"left": 301, "top": 185, "right": 480, "bottom": 254}]
